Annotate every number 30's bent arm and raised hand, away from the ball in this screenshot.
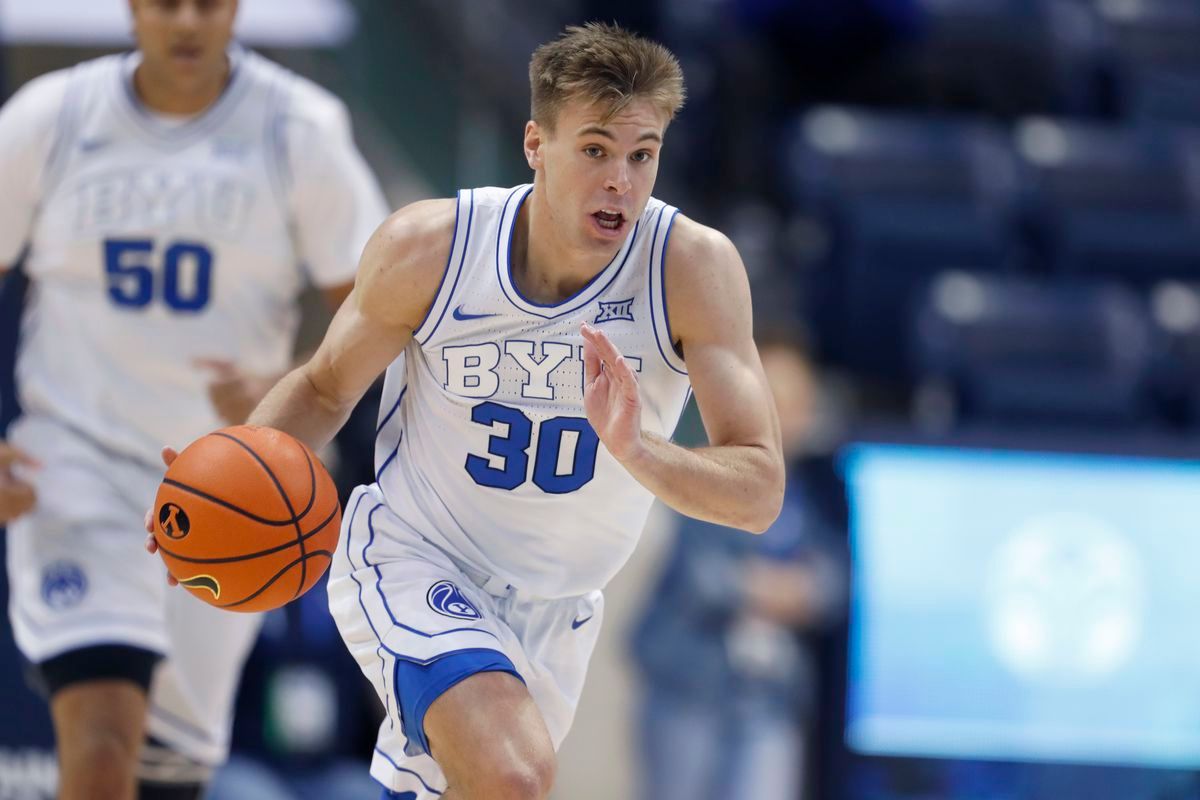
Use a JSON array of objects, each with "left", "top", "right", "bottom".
[{"left": 583, "top": 216, "right": 784, "bottom": 533}]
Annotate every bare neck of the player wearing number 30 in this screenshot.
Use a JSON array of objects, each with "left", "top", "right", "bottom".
[{"left": 511, "top": 186, "right": 620, "bottom": 303}]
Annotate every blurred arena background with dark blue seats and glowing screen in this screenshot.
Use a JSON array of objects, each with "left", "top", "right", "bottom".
[{"left": 0, "top": 0, "right": 1200, "bottom": 800}]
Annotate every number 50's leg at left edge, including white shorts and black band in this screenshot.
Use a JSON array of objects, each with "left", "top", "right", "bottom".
[{"left": 6, "top": 417, "right": 228, "bottom": 800}]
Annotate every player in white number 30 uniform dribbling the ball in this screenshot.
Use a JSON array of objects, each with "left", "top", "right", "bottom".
[{"left": 151, "top": 18, "right": 784, "bottom": 800}]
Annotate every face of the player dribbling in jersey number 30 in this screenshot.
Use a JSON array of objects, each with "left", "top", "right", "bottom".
[{"left": 526, "top": 100, "right": 668, "bottom": 247}]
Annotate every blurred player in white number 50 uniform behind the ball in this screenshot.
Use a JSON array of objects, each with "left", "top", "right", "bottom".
[{"left": 0, "top": 0, "right": 386, "bottom": 800}]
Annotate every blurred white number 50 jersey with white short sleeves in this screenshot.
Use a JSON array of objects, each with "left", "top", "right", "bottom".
[{"left": 0, "top": 48, "right": 386, "bottom": 464}]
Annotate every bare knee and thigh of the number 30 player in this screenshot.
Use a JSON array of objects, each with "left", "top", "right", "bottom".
[{"left": 425, "top": 672, "right": 557, "bottom": 800}]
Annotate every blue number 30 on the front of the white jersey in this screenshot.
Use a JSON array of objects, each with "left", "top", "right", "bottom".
[{"left": 466, "top": 403, "right": 600, "bottom": 494}]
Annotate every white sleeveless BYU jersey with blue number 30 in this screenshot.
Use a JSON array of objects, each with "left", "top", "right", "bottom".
[{"left": 376, "top": 186, "right": 689, "bottom": 597}]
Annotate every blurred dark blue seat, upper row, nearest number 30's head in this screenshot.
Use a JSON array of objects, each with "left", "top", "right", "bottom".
[{"left": 788, "top": 108, "right": 1015, "bottom": 379}]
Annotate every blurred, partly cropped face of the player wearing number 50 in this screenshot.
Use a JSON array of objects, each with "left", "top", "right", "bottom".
[{"left": 130, "top": 0, "right": 238, "bottom": 91}]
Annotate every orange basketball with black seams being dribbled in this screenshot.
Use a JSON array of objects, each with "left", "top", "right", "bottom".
[{"left": 154, "top": 425, "right": 342, "bottom": 612}]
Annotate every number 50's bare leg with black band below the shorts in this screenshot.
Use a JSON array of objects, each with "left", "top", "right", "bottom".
[{"left": 37, "top": 645, "right": 158, "bottom": 800}]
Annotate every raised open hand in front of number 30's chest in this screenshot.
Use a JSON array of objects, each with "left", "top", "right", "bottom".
[{"left": 580, "top": 323, "right": 642, "bottom": 461}]
